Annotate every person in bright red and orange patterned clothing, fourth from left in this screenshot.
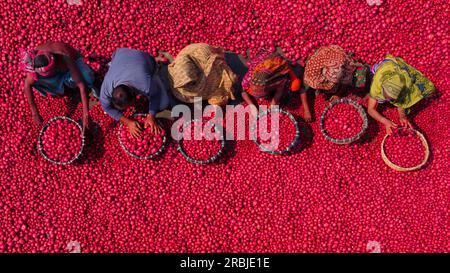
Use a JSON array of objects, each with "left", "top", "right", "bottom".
[{"left": 242, "top": 50, "right": 311, "bottom": 119}]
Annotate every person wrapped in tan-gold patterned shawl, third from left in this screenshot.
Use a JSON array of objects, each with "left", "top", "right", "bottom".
[{"left": 168, "top": 43, "right": 237, "bottom": 106}]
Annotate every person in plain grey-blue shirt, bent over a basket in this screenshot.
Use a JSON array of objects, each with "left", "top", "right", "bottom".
[{"left": 100, "top": 48, "right": 170, "bottom": 137}]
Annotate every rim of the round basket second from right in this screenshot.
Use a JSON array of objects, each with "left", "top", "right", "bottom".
[{"left": 320, "top": 98, "right": 369, "bottom": 144}]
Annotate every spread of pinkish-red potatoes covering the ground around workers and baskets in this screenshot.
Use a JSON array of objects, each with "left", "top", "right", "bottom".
[{"left": 0, "top": 0, "right": 450, "bottom": 252}]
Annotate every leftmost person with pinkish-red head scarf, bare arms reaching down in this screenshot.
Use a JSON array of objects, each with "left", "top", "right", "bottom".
[{"left": 21, "top": 42, "right": 95, "bottom": 129}]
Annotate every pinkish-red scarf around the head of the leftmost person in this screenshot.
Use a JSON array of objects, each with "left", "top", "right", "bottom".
[{"left": 20, "top": 50, "right": 55, "bottom": 80}]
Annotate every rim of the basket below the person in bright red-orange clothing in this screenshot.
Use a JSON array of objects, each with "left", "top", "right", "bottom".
[{"left": 252, "top": 108, "right": 300, "bottom": 155}]
